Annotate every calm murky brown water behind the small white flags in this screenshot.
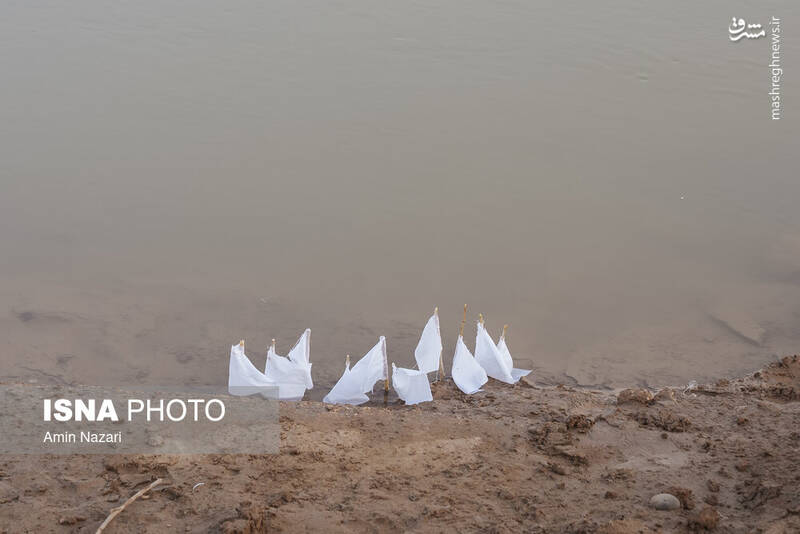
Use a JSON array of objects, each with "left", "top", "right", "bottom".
[{"left": 0, "top": 0, "right": 800, "bottom": 396}]
